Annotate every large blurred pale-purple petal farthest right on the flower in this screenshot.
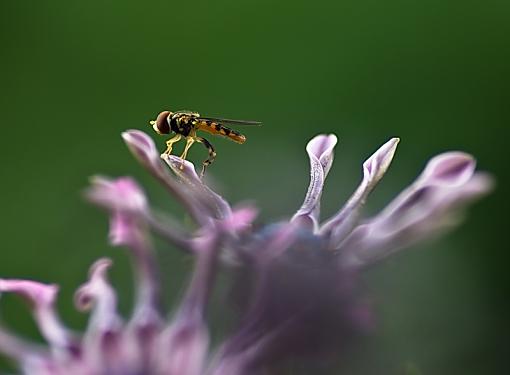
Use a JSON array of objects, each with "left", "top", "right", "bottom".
[{"left": 338, "top": 152, "right": 493, "bottom": 266}]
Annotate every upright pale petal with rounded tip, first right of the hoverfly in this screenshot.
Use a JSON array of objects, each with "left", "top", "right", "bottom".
[{"left": 292, "top": 134, "right": 337, "bottom": 230}]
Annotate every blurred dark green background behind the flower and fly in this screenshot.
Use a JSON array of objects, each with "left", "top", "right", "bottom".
[{"left": 0, "top": 0, "right": 510, "bottom": 374}]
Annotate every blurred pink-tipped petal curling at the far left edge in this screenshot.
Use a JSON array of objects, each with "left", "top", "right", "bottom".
[{"left": 0, "top": 279, "right": 71, "bottom": 349}]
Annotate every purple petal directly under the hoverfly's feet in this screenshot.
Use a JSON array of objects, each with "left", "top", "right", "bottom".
[{"left": 161, "top": 154, "right": 232, "bottom": 219}]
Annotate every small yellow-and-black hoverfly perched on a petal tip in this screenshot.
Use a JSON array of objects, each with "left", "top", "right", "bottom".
[{"left": 150, "top": 111, "right": 261, "bottom": 177}]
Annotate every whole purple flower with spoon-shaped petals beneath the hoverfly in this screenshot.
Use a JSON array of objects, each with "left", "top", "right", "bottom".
[{"left": 0, "top": 130, "right": 492, "bottom": 375}]
